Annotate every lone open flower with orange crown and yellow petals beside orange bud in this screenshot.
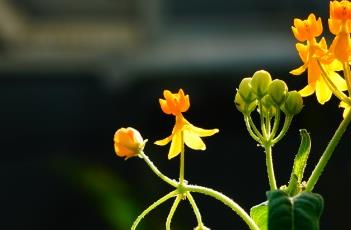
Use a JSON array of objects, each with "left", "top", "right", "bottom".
[{"left": 155, "top": 89, "right": 219, "bottom": 159}]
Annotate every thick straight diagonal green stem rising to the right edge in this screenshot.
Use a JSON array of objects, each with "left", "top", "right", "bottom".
[{"left": 306, "top": 108, "right": 351, "bottom": 192}]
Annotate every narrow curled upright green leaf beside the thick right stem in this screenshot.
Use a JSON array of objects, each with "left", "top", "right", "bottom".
[{"left": 288, "top": 129, "right": 311, "bottom": 195}]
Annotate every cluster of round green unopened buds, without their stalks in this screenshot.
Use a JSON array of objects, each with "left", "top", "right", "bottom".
[{"left": 234, "top": 70, "right": 303, "bottom": 117}]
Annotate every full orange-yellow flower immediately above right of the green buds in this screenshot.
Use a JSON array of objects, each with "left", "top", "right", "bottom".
[{"left": 290, "top": 14, "right": 347, "bottom": 104}]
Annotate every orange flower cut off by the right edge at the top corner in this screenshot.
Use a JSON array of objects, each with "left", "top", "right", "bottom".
[{"left": 328, "top": 0, "right": 351, "bottom": 62}]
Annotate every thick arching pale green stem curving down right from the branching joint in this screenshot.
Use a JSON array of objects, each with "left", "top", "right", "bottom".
[{"left": 185, "top": 185, "right": 259, "bottom": 230}]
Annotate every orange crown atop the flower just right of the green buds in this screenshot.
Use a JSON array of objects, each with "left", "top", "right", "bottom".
[{"left": 291, "top": 14, "right": 323, "bottom": 42}]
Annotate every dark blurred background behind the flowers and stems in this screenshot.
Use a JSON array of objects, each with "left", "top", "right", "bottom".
[{"left": 0, "top": 0, "right": 351, "bottom": 230}]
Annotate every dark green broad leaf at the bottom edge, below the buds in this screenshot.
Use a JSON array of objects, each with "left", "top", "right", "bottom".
[{"left": 267, "top": 190, "right": 323, "bottom": 230}]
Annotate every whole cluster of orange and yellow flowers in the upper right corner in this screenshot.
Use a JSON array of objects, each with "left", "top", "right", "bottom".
[{"left": 290, "top": 0, "right": 351, "bottom": 116}]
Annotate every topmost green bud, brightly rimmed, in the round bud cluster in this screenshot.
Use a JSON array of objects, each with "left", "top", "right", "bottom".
[{"left": 251, "top": 70, "right": 272, "bottom": 99}]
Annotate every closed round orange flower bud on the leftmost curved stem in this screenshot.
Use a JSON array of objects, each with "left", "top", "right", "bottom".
[{"left": 113, "top": 127, "right": 146, "bottom": 159}]
